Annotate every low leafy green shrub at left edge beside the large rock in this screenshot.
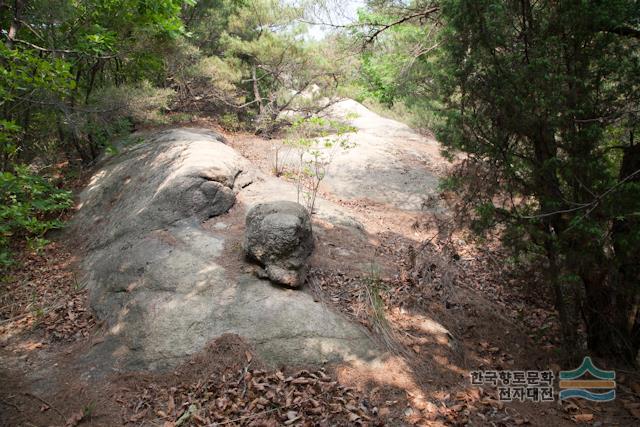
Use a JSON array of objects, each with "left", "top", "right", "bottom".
[{"left": 0, "top": 166, "right": 72, "bottom": 268}]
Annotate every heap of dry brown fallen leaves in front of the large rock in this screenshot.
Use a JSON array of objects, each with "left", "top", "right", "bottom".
[{"left": 124, "top": 364, "right": 381, "bottom": 427}]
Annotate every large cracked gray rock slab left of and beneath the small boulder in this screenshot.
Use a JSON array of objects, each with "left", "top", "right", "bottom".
[{"left": 71, "top": 128, "right": 379, "bottom": 371}]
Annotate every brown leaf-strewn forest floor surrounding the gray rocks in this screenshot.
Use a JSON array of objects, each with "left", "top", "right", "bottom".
[{"left": 0, "top": 103, "right": 640, "bottom": 427}]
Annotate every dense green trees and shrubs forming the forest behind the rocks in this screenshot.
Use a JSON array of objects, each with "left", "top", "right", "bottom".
[{"left": 0, "top": 0, "right": 640, "bottom": 368}]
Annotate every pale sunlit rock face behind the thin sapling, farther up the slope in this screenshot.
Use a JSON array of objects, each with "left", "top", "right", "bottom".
[{"left": 322, "top": 99, "right": 442, "bottom": 211}]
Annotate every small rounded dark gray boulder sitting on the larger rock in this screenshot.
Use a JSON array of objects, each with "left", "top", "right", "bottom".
[{"left": 244, "top": 200, "right": 313, "bottom": 288}]
